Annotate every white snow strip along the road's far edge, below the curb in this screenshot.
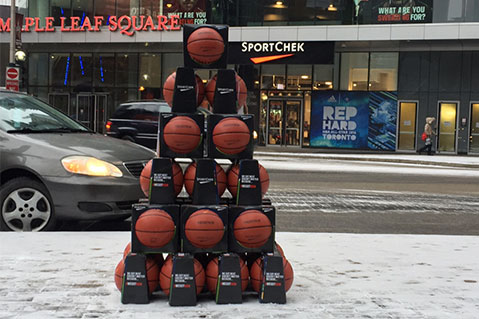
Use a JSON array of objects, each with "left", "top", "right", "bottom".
[{"left": 256, "top": 155, "right": 479, "bottom": 177}]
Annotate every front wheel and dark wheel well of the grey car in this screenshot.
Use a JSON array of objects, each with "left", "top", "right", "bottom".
[{"left": 0, "top": 177, "right": 55, "bottom": 231}]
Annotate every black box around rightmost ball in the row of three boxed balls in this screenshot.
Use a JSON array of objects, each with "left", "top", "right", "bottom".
[{"left": 228, "top": 206, "right": 276, "bottom": 253}]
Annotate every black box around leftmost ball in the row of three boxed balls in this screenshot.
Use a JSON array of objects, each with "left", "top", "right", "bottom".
[{"left": 131, "top": 204, "right": 180, "bottom": 254}]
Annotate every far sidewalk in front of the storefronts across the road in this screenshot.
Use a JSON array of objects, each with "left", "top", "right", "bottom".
[{"left": 254, "top": 146, "right": 479, "bottom": 168}]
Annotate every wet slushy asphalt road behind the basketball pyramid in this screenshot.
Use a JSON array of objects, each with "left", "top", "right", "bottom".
[{"left": 60, "top": 160, "right": 479, "bottom": 235}]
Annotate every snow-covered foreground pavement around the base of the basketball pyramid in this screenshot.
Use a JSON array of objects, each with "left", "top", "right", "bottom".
[{"left": 0, "top": 232, "right": 479, "bottom": 319}]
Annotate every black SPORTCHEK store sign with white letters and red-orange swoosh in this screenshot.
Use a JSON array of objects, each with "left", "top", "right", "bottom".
[{"left": 228, "top": 41, "right": 334, "bottom": 64}]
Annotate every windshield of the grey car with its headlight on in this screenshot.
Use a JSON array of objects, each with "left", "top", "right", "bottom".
[{"left": 0, "top": 92, "right": 90, "bottom": 133}]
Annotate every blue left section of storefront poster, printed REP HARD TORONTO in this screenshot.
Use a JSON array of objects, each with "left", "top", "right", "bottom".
[{"left": 310, "top": 91, "right": 369, "bottom": 148}]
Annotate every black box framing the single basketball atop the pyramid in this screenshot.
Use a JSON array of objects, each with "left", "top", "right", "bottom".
[{"left": 183, "top": 24, "right": 228, "bottom": 69}]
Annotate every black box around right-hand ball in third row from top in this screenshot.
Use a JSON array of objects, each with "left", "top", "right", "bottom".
[{"left": 206, "top": 114, "right": 254, "bottom": 160}]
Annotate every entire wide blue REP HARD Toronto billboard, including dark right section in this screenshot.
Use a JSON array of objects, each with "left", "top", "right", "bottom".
[{"left": 310, "top": 91, "right": 397, "bottom": 151}]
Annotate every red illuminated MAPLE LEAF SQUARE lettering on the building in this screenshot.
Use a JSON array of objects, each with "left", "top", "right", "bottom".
[{"left": 0, "top": 15, "right": 181, "bottom": 36}]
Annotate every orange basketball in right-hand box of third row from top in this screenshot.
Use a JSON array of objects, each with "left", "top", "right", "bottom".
[{"left": 213, "top": 117, "right": 251, "bottom": 155}]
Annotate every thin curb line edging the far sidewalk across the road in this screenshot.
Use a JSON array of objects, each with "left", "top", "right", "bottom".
[{"left": 254, "top": 151, "right": 479, "bottom": 168}]
